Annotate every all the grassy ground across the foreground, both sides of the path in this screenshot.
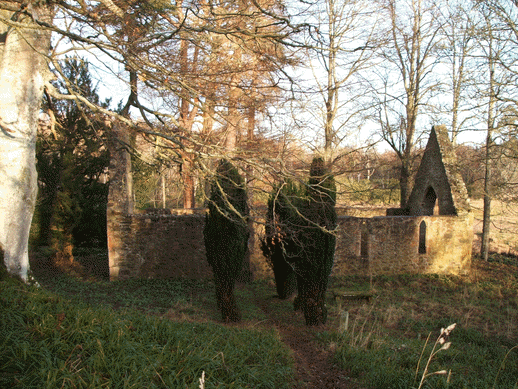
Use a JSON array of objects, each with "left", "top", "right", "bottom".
[{"left": 0, "top": 250, "right": 518, "bottom": 389}]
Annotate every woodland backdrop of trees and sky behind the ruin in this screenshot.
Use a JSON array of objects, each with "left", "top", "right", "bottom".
[{"left": 22, "top": 0, "right": 518, "bottom": 264}]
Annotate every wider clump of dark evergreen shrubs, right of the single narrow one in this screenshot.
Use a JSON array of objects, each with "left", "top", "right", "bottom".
[{"left": 262, "top": 158, "right": 337, "bottom": 325}]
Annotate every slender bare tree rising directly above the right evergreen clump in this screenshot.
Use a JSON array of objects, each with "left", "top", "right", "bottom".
[{"left": 303, "top": 0, "right": 377, "bottom": 163}]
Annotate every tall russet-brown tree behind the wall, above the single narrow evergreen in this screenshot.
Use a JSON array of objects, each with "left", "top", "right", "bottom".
[{"left": 144, "top": 1, "right": 294, "bottom": 208}]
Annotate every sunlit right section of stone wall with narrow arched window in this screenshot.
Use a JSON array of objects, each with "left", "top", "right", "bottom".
[{"left": 333, "top": 214, "right": 473, "bottom": 275}]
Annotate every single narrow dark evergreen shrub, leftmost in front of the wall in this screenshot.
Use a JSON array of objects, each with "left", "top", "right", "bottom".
[{"left": 203, "top": 159, "right": 249, "bottom": 322}]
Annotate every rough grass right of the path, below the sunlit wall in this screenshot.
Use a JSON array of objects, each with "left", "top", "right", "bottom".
[{"left": 322, "top": 256, "right": 518, "bottom": 389}]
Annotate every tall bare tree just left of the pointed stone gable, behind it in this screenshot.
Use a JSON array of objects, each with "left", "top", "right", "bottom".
[{"left": 374, "top": 0, "right": 441, "bottom": 208}]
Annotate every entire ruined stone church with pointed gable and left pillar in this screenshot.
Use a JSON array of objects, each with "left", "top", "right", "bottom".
[{"left": 108, "top": 126, "right": 473, "bottom": 280}]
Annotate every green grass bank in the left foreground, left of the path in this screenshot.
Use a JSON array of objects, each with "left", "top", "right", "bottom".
[{"left": 0, "top": 274, "right": 293, "bottom": 388}]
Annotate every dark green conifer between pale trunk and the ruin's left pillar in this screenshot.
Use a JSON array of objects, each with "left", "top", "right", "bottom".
[{"left": 36, "top": 59, "right": 109, "bottom": 261}]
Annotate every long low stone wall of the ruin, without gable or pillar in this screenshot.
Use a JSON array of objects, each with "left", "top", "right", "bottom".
[{"left": 110, "top": 212, "right": 473, "bottom": 279}]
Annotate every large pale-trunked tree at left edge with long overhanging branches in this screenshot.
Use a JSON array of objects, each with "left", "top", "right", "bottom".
[{"left": 0, "top": 0, "right": 300, "bottom": 279}]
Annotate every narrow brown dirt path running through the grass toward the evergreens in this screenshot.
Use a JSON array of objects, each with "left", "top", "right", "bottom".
[{"left": 256, "top": 284, "right": 358, "bottom": 389}]
